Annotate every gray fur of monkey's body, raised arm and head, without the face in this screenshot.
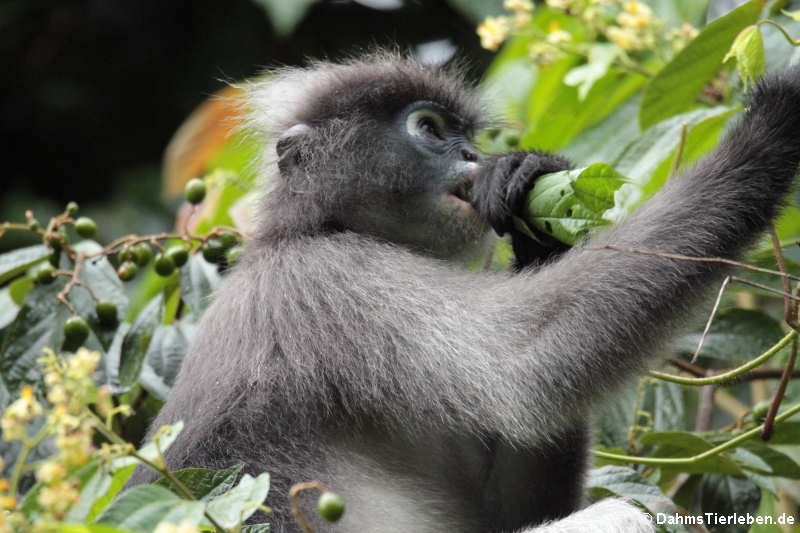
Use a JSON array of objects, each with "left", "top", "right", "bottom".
[{"left": 128, "top": 54, "right": 800, "bottom": 533}]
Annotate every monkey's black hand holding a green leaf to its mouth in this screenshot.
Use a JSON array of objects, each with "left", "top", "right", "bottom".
[{"left": 472, "top": 152, "right": 572, "bottom": 270}]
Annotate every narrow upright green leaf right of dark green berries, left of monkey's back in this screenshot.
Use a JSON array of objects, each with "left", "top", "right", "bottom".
[{"left": 113, "top": 293, "right": 164, "bottom": 391}]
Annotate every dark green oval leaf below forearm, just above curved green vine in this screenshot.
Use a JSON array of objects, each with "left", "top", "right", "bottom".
[{"left": 673, "top": 308, "right": 783, "bottom": 361}]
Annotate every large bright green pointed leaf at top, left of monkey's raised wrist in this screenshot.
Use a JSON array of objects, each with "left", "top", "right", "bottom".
[{"left": 639, "top": 1, "right": 762, "bottom": 130}]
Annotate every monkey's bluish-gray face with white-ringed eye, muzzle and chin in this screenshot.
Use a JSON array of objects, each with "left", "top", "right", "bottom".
[{"left": 343, "top": 101, "right": 488, "bottom": 257}]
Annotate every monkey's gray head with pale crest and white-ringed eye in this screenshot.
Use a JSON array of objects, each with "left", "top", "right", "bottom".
[{"left": 244, "top": 54, "right": 489, "bottom": 257}]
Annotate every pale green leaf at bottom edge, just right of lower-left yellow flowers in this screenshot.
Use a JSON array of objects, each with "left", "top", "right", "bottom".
[{"left": 96, "top": 485, "right": 205, "bottom": 531}]
